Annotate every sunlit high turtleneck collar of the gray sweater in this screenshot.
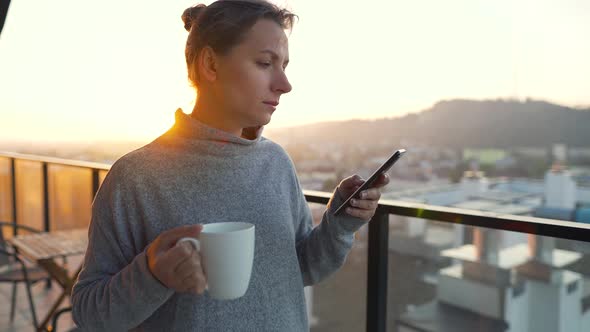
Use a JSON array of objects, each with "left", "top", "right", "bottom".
[{"left": 172, "top": 108, "right": 263, "bottom": 146}]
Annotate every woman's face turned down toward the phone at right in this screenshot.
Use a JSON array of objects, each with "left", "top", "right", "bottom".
[{"left": 213, "top": 19, "right": 291, "bottom": 128}]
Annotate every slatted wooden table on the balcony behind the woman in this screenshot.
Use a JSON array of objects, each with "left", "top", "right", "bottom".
[{"left": 8, "top": 229, "right": 88, "bottom": 331}]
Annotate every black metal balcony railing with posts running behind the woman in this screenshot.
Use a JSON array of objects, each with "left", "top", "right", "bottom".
[{"left": 0, "top": 153, "right": 590, "bottom": 331}]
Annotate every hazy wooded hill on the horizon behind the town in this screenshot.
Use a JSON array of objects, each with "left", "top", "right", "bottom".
[{"left": 266, "top": 99, "right": 590, "bottom": 148}]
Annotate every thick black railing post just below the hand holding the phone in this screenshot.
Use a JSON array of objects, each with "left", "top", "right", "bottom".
[{"left": 367, "top": 210, "right": 389, "bottom": 332}]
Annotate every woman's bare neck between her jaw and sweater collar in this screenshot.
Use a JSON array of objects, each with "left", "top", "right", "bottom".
[{"left": 191, "top": 96, "right": 243, "bottom": 137}]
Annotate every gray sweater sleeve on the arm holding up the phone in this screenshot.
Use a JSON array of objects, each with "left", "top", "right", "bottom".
[{"left": 296, "top": 179, "right": 365, "bottom": 286}]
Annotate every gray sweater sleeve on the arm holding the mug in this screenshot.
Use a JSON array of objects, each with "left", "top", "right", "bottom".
[{"left": 71, "top": 165, "right": 174, "bottom": 331}]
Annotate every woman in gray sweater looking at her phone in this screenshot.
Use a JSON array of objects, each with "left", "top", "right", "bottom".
[{"left": 72, "top": 0, "right": 389, "bottom": 331}]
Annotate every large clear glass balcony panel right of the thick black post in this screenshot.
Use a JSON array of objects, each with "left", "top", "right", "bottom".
[{"left": 387, "top": 216, "right": 590, "bottom": 332}]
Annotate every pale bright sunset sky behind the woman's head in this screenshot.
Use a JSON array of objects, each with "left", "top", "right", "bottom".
[{"left": 0, "top": 0, "right": 590, "bottom": 141}]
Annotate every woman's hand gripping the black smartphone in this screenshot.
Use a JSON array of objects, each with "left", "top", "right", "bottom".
[{"left": 337, "top": 174, "right": 389, "bottom": 221}]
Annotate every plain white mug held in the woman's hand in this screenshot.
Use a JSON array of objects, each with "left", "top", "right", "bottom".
[{"left": 177, "top": 222, "right": 254, "bottom": 300}]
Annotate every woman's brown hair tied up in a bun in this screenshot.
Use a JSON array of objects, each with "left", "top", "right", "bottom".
[{"left": 182, "top": 0, "right": 297, "bottom": 87}]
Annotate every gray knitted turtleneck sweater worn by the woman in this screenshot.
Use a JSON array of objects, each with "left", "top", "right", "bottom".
[{"left": 72, "top": 110, "right": 364, "bottom": 331}]
